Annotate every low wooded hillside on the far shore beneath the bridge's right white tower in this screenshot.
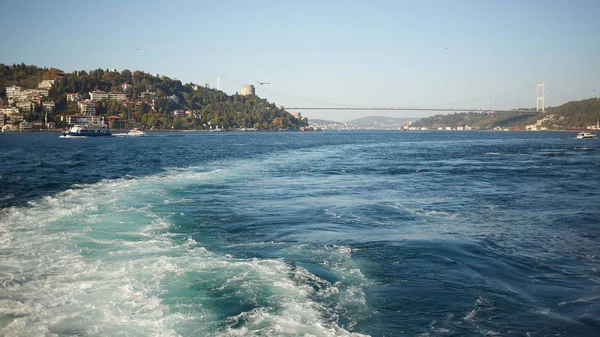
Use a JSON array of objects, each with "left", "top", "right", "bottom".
[{"left": 413, "top": 98, "right": 600, "bottom": 130}]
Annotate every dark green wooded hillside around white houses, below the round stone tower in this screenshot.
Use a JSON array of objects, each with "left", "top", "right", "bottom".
[{"left": 0, "top": 64, "right": 308, "bottom": 130}]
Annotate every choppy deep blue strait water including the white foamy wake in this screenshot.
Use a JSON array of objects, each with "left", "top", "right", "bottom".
[{"left": 0, "top": 132, "right": 600, "bottom": 336}]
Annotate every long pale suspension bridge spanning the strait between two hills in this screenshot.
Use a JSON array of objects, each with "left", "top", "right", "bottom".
[{"left": 207, "top": 76, "right": 575, "bottom": 112}]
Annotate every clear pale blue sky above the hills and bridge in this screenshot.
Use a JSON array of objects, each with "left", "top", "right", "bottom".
[{"left": 0, "top": 0, "right": 600, "bottom": 120}]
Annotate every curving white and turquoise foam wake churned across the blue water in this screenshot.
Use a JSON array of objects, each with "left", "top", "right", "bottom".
[{"left": 0, "top": 169, "right": 364, "bottom": 336}]
